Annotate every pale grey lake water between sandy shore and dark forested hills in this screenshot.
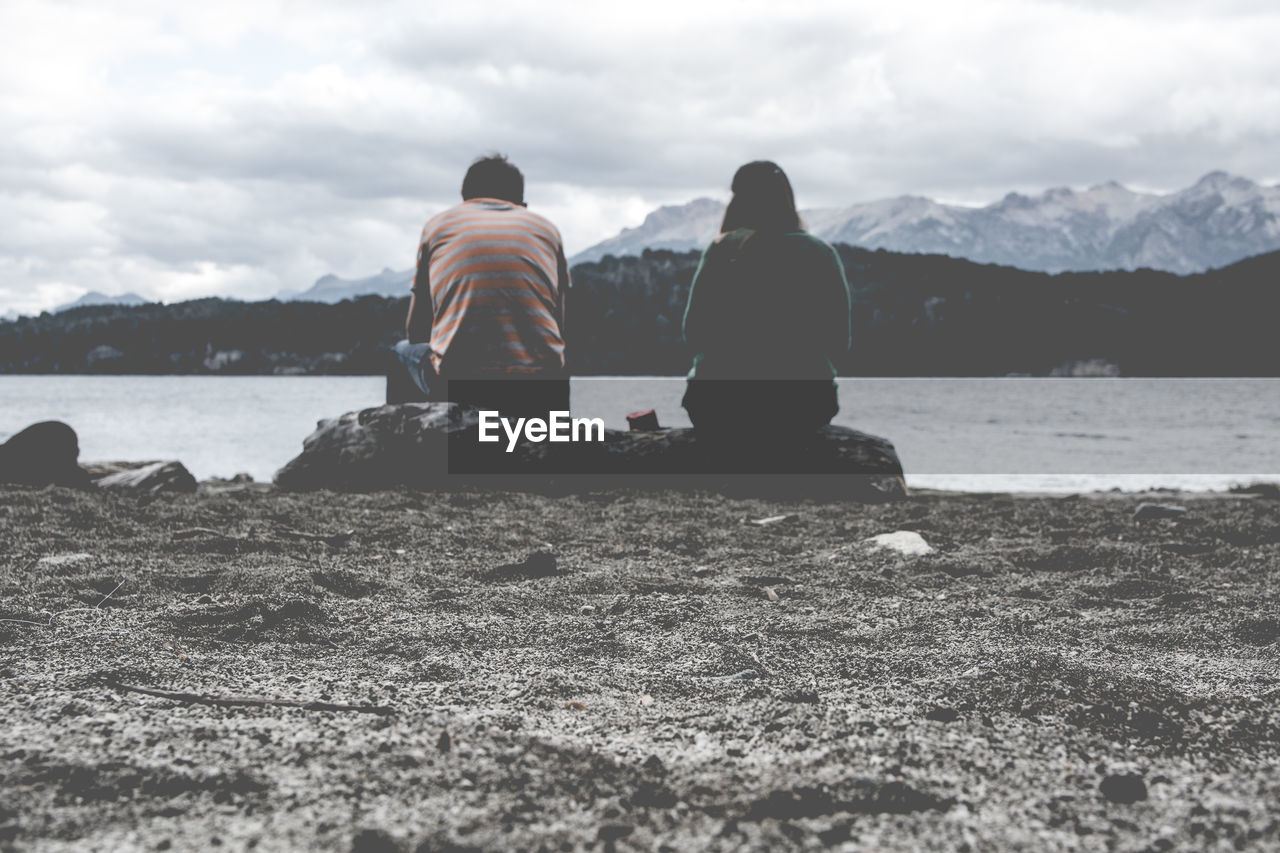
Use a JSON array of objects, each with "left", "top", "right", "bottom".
[{"left": 0, "top": 375, "right": 1280, "bottom": 492}]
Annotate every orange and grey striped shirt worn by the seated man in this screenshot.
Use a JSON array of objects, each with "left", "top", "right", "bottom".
[{"left": 413, "top": 199, "right": 568, "bottom": 375}]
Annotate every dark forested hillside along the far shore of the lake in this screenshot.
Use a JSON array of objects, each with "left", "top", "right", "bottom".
[{"left": 0, "top": 246, "right": 1280, "bottom": 375}]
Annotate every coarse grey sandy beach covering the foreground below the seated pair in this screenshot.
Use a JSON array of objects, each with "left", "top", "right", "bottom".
[{"left": 0, "top": 485, "right": 1280, "bottom": 850}]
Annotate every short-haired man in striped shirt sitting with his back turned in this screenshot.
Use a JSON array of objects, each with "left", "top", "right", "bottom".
[{"left": 388, "top": 154, "right": 570, "bottom": 416}]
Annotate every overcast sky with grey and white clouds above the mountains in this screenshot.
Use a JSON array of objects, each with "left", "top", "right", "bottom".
[{"left": 0, "top": 0, "right": 1280, "bottom": 314}]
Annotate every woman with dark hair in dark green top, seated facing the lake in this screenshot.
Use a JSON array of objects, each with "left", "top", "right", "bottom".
[{"left": 684, "top": 160, "right": 850, "bottom": 437}]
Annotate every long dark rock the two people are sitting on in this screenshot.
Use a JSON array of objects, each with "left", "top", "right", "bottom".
[{"left": 275, "top": 402, "right": 906, "bottom": 501}]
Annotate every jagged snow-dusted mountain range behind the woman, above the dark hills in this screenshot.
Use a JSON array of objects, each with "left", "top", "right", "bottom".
[{"left": 572, "top": 172, "right": 1280, "bottom": 273}]
